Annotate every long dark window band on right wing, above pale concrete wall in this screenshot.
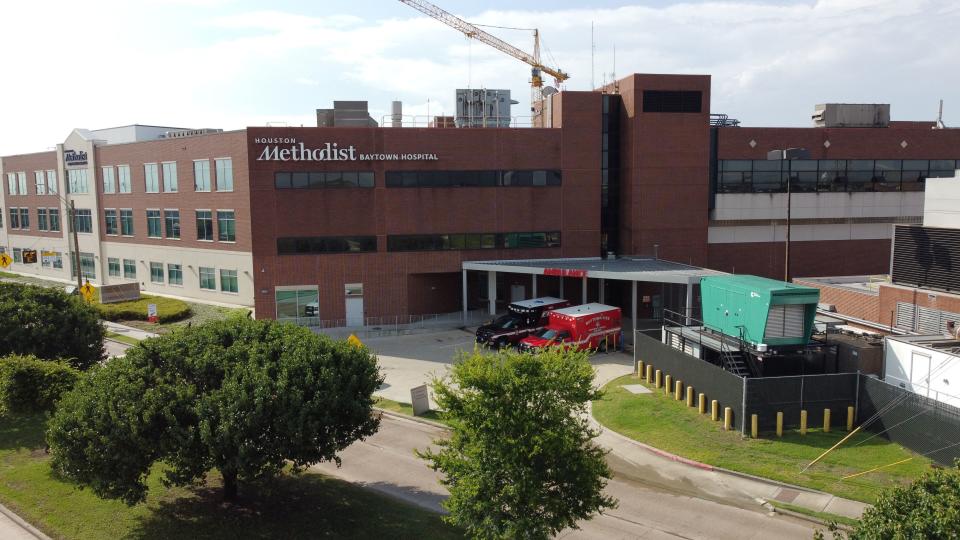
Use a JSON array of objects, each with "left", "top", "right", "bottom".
[{"left": 717, "top": 159, "right": 960, "bottom": 193}]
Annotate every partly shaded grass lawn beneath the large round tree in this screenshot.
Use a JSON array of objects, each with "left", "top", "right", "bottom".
[{"left": 0, "top": 416, "right": 463, "bottom": 539}]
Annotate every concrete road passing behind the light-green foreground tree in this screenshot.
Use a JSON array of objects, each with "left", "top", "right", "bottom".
[{"left": 313, "top": 415, "right": 814, "bottom": 540}]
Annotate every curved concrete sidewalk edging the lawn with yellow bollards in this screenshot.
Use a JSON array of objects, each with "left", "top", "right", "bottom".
[{"left": 589, "top": 364, "right": 869, "bottom": 519}]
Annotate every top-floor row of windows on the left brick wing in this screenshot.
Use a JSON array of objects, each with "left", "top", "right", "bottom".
[{"left": 7, "top": 158, "right": 233, "bottom": 195}]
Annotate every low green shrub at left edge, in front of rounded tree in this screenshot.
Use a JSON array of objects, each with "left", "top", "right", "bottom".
[{"left": 0, "top": 354, "right": 80, "bottom": 414}]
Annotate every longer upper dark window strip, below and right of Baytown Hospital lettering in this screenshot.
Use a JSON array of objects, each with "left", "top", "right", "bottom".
[{"left": 386, "top": 169, "right": 562, "bottom": 187}]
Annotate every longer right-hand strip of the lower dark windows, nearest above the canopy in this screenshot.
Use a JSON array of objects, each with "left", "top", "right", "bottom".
[{"left": 387, "top": 231, "right": 560, "bottom": 251}]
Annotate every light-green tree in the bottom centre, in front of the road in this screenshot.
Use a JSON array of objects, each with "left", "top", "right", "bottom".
[{"left": 418, "top": 349, "right": 616, "bottom": 539}]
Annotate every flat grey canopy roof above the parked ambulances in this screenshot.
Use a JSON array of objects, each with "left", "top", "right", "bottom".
[{"left": 463, "top": 257, "right": 726, "bottom": 285}]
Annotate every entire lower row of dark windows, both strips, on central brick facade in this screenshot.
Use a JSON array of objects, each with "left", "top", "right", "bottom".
[{"left": 277, "top": 231, "right": 560, "bottom": 255}]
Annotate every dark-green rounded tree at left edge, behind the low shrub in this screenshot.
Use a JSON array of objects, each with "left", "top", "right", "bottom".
[{"left": 0, "top": 283, "right": 104, "bottom": 369}]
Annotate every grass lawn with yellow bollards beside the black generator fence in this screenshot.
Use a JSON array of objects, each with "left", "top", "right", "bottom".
[{"left": 593, "top": 375, "right": 930, "bottom": 503}]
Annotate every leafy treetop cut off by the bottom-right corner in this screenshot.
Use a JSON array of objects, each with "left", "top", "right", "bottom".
[{"left": 814, "top": 461, "right": 960, "bottom": 540}]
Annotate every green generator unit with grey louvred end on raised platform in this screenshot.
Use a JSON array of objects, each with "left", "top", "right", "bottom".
[{"left": 700, "top": 275, "right": 820, "bottom": 351}]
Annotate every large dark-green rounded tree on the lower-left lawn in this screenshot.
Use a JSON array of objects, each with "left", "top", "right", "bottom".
[{"left": 47, "top": 318, "right": 383, "bottom": 505}]
